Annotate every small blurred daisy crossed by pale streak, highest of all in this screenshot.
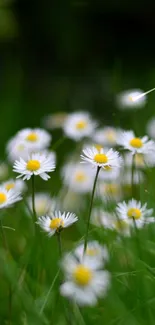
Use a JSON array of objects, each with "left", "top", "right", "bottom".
[{"left": 117, "top": 89, "right": 146, "bottom": 110}]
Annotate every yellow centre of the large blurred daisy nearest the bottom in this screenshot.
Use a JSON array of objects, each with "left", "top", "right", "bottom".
[{"left": 73, "top": 264, "right": 93, "bottom": 286}]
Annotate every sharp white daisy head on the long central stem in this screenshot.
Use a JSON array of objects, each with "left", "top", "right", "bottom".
[{"left": 81, "top": 147, "right": 122, "bottom": 168}]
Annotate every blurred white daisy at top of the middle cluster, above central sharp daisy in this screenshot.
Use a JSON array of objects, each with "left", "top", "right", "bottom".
[{"left": 64, "top": 112, "right": 96, "bottom": 141}]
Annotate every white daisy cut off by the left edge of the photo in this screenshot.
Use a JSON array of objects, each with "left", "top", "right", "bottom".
[{"left": 0, "top": 186, "right": 22, "bottom": 209}]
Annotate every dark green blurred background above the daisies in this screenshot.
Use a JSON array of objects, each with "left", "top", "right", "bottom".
[{"left": 0, "top": 0, "right": 155, "bottom": 152}]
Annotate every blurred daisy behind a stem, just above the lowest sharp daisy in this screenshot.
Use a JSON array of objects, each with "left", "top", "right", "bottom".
[{"left": 27, "top": 193, "right": 56, "bottom": 217}]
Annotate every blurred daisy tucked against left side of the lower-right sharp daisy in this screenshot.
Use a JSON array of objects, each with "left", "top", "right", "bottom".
[{"left": 91, "top": 209, "right": 130, "bottom": 236}]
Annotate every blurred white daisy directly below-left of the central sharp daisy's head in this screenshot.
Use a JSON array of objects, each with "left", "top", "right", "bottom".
[{"left": 62, "top": 162, "right": 94, "bottom": 193}]
